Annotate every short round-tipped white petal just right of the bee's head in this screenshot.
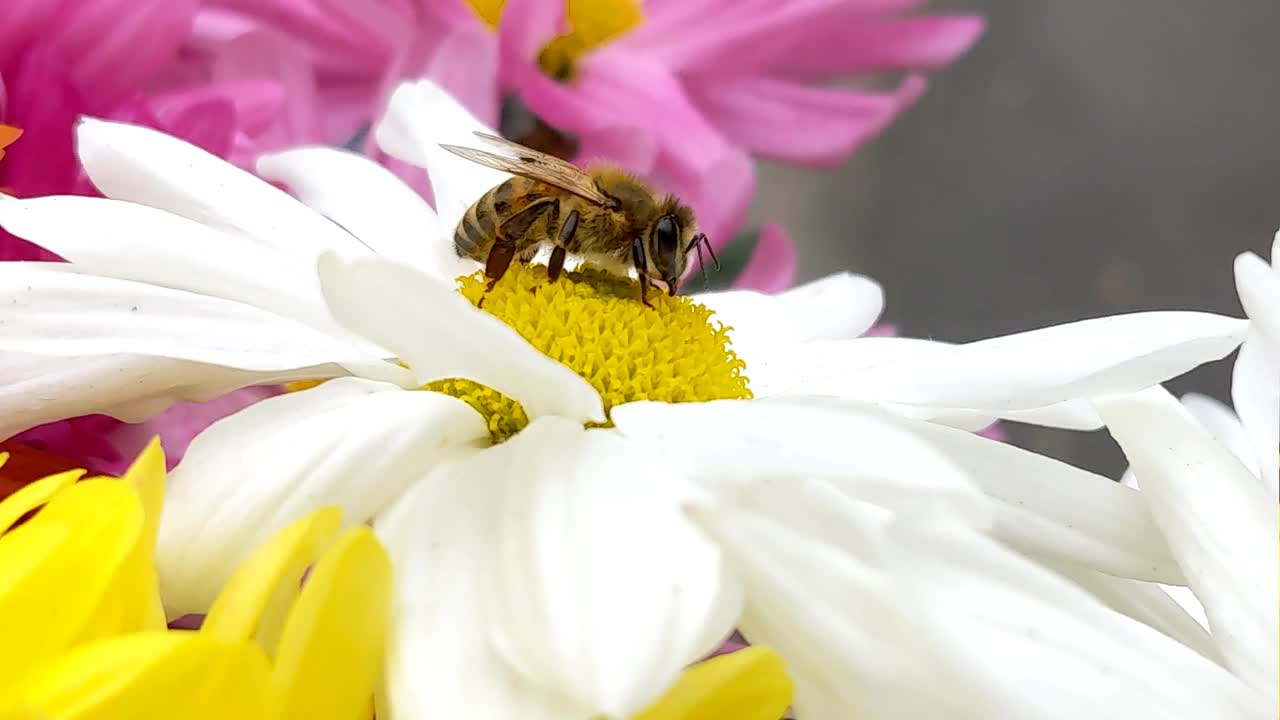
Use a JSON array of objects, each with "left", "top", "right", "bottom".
[{"left": 692, "top": 273, "right": 884, "bottom": 366}]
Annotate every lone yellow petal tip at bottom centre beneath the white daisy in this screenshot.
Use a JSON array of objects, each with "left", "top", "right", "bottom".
[{"left": 636, "top": 647, "right": 792, "bottom": 720}]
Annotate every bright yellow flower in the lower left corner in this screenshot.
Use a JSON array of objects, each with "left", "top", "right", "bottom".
[{"left": 0, "top": 442, "right": 390, "bottom": 720}]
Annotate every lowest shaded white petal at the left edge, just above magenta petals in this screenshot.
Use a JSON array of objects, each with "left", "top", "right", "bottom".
[{"left": 0, "top": 352, "right": 330, "bottom": 438}]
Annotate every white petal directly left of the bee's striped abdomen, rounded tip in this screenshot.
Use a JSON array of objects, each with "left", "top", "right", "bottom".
[{"left": 257, "top": 147, "right": 458, "bottom": 272}]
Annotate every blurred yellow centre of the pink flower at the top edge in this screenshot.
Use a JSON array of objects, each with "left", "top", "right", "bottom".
[{"left": 467, "top": 0, "right": 644, "bottom": 81}]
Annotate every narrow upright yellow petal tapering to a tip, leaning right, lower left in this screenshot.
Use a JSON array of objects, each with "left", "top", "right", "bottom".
[{"left": 201, "top": 506, "right": 342, "bottom": 655}]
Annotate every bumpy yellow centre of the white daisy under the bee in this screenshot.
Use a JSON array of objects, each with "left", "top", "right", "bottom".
[{"left": 432, "top": 263, "right": 751, "bottom": 442}]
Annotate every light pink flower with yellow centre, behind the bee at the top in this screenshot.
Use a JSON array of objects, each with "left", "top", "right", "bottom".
[{"left": 185, "top": 0, "right": 982, "bottom": 287}]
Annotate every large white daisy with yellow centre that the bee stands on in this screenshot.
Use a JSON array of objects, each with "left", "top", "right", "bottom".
[{"left": 0, "top": 75, "right": 1244, "bottom": 717}]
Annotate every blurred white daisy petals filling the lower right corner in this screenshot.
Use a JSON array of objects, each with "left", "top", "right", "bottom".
[{"left": 689, "top": 388, "right": 1280, "bottom": 720}]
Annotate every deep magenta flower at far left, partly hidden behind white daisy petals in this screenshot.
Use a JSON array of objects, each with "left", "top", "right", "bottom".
[{"left": 0, "top": 0, "right": 288, "bottom": 473}]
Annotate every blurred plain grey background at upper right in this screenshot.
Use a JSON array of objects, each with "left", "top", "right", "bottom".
[{"left": 753, "top": 0, "right": 1280, "bottom": 477}]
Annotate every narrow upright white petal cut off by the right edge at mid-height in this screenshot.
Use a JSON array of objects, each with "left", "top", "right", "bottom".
[{"left": 1231, "top": 329, "right": 1280, "bottom": 496}]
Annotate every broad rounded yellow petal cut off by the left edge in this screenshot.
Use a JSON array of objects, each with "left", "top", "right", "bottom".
[{"left": 0, "top": 480, "right": 142, "bottom": 684}]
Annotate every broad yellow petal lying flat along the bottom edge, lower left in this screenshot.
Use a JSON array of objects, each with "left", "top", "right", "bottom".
[{"left": 12, "top": 632, "right": 270, "bottom": 720}]
